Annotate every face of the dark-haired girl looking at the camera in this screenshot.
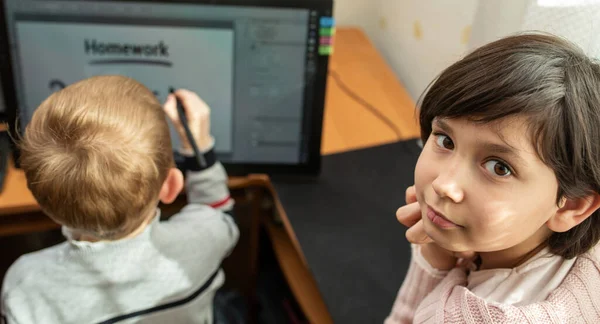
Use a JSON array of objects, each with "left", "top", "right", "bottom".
[{"left": 415, "top": 117, "right": 558, "bottom": 255}]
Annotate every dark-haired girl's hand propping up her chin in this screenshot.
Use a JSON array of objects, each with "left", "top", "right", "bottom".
[{"left": 396, "top": 186, "right": 475, "bottom": 270}]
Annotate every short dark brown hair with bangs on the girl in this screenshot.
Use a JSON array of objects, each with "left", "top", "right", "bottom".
[{"left": 419, "top": 33, "right": 600, "bottom": 259}]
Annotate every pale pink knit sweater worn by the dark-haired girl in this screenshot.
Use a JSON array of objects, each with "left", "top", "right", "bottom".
[{"left": 385, "top": 247, "right": 600, "bottom": 324}]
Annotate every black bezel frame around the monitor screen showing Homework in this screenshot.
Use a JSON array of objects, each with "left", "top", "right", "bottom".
[{"left": 0, "top": 0, "right": 333, "bottom": 175}]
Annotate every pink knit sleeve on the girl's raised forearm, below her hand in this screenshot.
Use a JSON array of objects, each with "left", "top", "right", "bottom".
[{"left": 384, "top": 244, "right": 448, "bottom": 324}]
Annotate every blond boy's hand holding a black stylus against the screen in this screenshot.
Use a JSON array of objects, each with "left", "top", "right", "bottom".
[{"left": 163, "top": 89, "right": 214, "bottom": 152}]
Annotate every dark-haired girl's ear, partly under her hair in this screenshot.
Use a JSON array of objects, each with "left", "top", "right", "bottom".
[{"left": 546, "top": 193, "right": 600, "bottom": 232}]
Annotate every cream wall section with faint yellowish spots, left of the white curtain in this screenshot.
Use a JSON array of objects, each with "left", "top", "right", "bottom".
[{"left": 376, "top": 0, "right": 477, "bottom": 99}]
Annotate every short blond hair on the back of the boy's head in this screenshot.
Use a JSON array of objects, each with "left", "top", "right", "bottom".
[{"left": 20, "top": 76, "right": 174, "bottom": 239}]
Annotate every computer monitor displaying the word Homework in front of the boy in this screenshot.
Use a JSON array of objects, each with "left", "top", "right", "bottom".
[{"left": 0, "top": 0, "right": 333, "bottom": 174}]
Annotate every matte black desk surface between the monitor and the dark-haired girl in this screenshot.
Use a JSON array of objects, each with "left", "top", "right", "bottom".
[{"left": 273, "top": 140, "right": 420, "bottom": 324}]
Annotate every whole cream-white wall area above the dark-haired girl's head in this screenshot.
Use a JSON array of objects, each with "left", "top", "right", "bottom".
[{"left": 335, "top": 0, "right": 600, "bottom": 100}]
